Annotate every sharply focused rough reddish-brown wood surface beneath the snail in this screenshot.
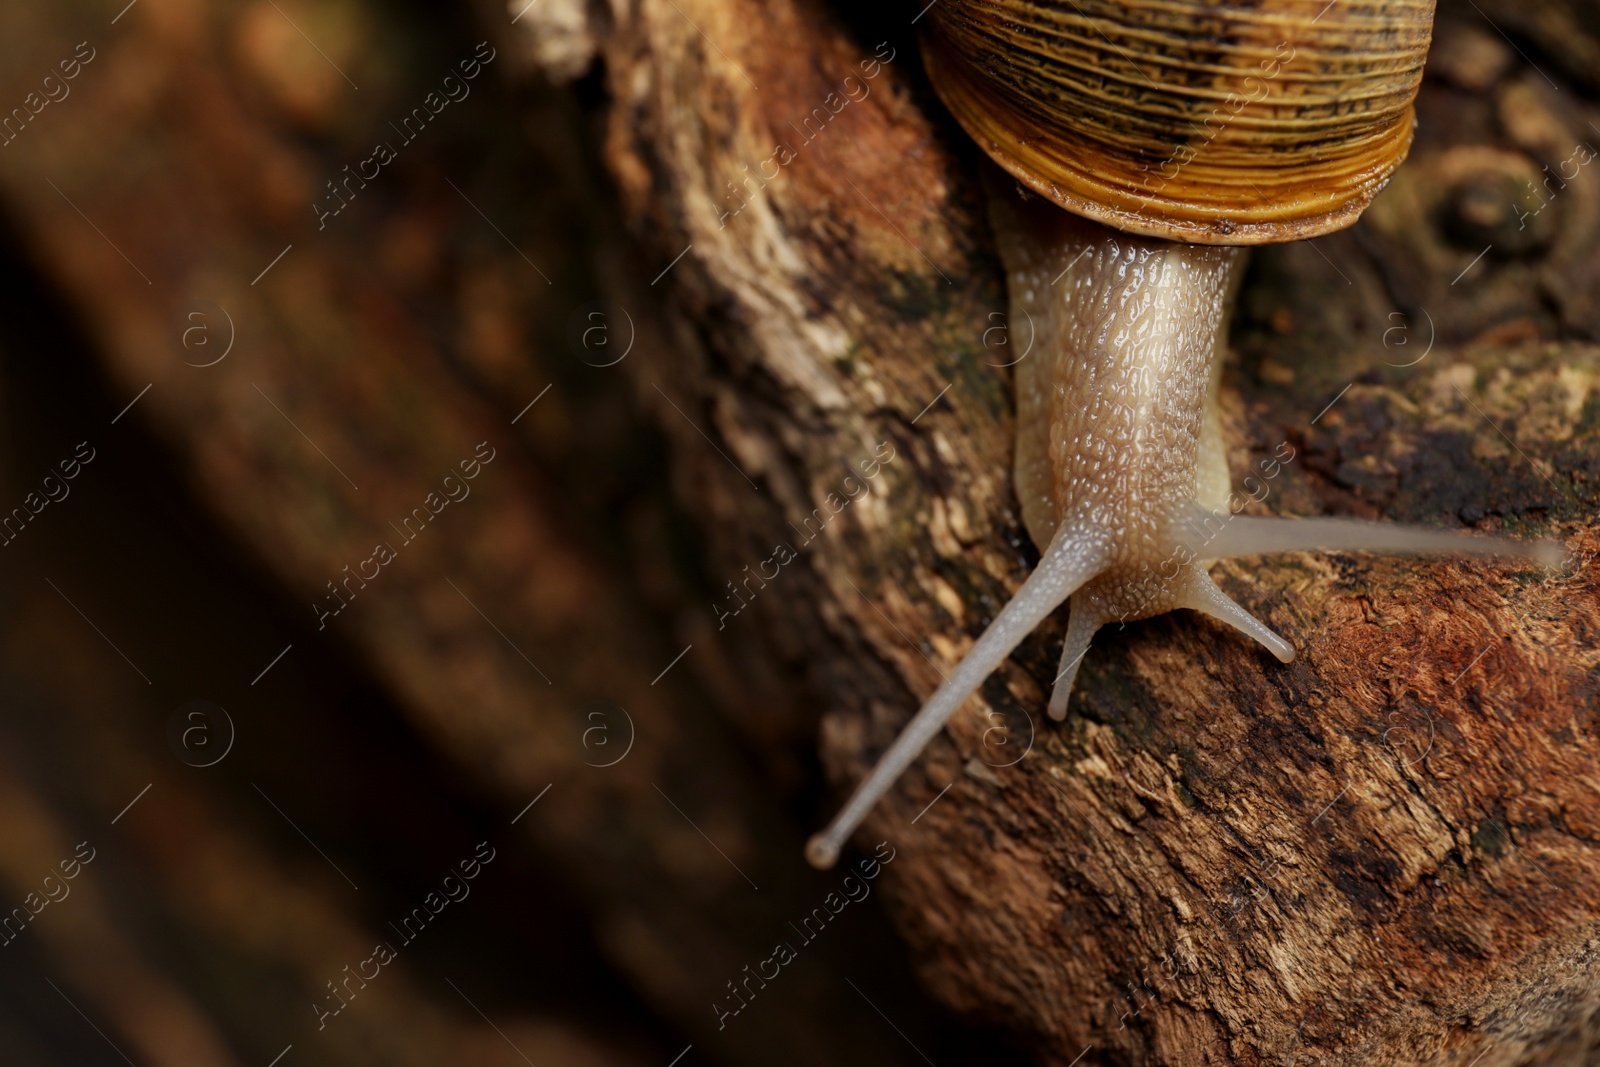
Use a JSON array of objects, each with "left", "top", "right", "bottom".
[{"left": 576, "top": 0, "right": 1600, "bottom": 1067}]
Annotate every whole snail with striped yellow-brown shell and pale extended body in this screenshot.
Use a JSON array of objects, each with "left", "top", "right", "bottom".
[{"left": 806, "top": 0, "right": 1563, "bottom": 867}]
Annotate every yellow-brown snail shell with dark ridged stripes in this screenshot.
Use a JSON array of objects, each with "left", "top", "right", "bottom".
[{"left": 923, "top": 0, "right": 1434, "bottom": 245}]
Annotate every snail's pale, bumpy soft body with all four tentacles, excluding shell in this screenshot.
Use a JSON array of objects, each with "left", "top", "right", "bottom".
[{"left": 806, "top": 182, "right": 1565, "bottom": 867}]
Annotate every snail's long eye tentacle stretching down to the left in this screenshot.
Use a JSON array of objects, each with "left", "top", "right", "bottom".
[{"left": 805, "top": 522, "right": 1109, "bottom": 870}]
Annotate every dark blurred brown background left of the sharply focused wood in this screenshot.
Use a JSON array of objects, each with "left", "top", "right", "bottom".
[{"left": 0, "top": 0, "right": 1030, "bottom": 1067}]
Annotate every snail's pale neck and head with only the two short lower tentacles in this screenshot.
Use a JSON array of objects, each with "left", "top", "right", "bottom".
[{"left": 992, "top": 197, "right": 1260, "bottom": 718}]
